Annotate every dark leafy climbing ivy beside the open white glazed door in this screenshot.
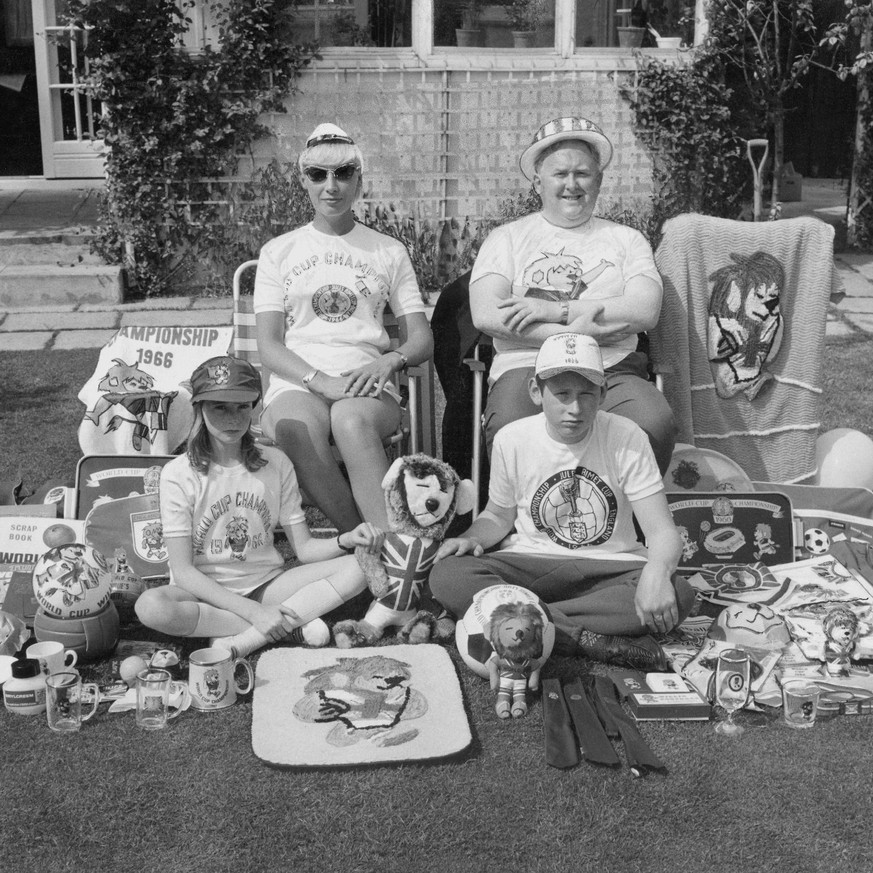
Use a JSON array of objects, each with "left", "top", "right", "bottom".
[{"left": 69, "top": 0, "right": 318, "bottom": 295}]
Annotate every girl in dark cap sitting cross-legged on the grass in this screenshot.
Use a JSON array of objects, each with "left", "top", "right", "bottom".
[{"left": 136, "top": 356, "right": 382, "bottom": 657}]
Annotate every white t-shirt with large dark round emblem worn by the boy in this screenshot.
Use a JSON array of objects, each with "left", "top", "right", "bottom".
[{"left": 488, "top": 410, "right": 664, "bottom": 562}]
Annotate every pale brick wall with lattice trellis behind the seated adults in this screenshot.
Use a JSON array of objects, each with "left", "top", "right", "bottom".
[{"left": 259, "top": 70, "right": 651, "bottom": 219}]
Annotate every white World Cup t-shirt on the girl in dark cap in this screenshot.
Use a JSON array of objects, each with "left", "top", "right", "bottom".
[{"left": 161, "top": 446, "right": 306, "bottom": 594}]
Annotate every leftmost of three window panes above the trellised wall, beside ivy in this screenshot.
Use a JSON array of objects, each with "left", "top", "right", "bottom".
[{"left": 283, "top": 0, "right": 412, "bottom": 48}]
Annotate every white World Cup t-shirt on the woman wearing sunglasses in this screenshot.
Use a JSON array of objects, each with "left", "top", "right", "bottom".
[{"left": 254, "top": 224, "right": 425, "bottom": 405}]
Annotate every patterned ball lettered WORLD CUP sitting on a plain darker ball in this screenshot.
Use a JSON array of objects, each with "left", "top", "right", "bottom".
[{"left": 33, "top": 543, "right": 112, "bottom": 618}]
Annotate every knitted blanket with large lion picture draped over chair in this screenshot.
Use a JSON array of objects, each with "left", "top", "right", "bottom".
[{"left": 651, "top": 214, "right": 840, "bottom": 482}]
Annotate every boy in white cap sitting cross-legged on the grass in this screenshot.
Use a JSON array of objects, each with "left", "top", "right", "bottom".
[{"left": 430, "top": 333, "right": 694, "bottom": 671}]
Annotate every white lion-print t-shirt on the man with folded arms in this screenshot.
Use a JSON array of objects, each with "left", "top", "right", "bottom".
[{"left": 470, "top": 212, "right": 662, "bottom": 383}]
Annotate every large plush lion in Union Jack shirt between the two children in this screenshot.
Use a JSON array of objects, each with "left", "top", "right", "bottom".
[{"left": 333, "top": 454, "right": 474, "bottom": 649}]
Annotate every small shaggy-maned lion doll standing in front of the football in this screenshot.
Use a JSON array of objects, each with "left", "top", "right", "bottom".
[{"left": 485, "top": 603, "right": 543, "bottom": 718}]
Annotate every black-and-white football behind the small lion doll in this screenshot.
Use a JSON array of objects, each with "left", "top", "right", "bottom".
[{"left": 455, "top": 585, "right": 555, "bottom": 679}]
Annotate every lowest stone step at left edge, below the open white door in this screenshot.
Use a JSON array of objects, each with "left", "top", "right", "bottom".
[{"left": 0, "top": 263, "right": 124, "bottom": 308}]
